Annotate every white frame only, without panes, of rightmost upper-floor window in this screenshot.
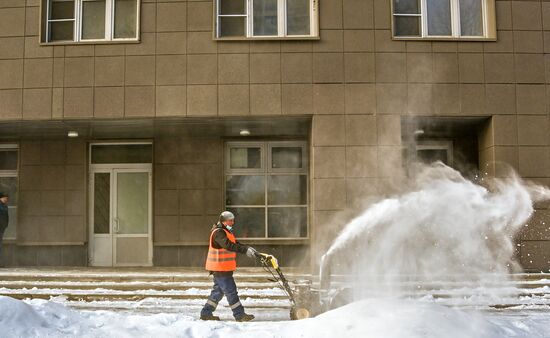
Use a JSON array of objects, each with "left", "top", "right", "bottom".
[{"left": 390, "top": 0, "right": 496, "bottom": 40}]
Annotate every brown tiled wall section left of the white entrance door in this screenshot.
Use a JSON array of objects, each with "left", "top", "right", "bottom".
[{"left": 17, "top": 140, "right": 87, "bottom": 245}]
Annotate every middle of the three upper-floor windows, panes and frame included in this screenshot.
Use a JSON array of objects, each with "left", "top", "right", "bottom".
[{"left": 215, "top": 0, "right": 319, "bottom": 39}]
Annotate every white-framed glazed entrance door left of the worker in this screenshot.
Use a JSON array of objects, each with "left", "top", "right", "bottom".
[{"left": 89, "top": 141, "right": 153, "bottom": 266}]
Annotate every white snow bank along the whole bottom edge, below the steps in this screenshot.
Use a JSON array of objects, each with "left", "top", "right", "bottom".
[{"left": 0, "top": 297, "right": 550, "bottom": 338}]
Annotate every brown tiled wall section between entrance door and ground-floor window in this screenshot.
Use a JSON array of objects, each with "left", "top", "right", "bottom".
[{"left": 153, "top": 137, "right": 223, "bottom": 246}]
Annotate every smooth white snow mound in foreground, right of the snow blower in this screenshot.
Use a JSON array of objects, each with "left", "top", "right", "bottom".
[{"left": 300, "top": 298, "right": 550, "bottom": 338}]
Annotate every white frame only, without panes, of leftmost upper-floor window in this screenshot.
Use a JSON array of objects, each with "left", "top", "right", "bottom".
[{"left": 45, "top": 0, "right": 141, "bottom": 43}]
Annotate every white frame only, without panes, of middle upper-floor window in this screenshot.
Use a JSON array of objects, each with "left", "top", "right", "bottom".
[{"left": 214, "top": 0, "right": 319, "bottom": 40}]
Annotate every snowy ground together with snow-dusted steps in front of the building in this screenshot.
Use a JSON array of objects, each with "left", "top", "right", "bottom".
[{"left": 0, "top": 269, "right": 550, "bottom": 338}]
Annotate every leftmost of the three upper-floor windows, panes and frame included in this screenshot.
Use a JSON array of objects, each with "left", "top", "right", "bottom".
[{"left": 42, "top": 0, "right": 139, "bottom": 42}]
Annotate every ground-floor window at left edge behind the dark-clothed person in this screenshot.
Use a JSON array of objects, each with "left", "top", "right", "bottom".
[{"left": 0, "top": 144, "right": 19, "bottom": 239}]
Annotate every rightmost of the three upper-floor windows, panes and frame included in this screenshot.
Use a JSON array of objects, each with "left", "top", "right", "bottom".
[{"left": 392, "top": 0, "right": 496, "bottom": 39}]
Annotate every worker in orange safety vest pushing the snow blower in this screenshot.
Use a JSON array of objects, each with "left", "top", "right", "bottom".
[{"left": 200, "top": 211, "right": 259, "bottom": 322}]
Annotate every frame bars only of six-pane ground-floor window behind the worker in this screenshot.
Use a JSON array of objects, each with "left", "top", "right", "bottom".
[{"left": 223, "top": 141, "right": 310, "bottom": 241}]
